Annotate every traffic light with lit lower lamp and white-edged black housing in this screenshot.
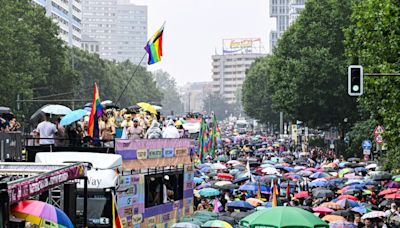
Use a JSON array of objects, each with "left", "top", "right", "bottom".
[{"left": 347, "top": 65, "right": 364, "bottom": 96}]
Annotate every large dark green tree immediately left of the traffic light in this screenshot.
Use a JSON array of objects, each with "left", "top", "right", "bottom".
[{"left": 267, "top": 0, "right": 357, "bottom": 127}]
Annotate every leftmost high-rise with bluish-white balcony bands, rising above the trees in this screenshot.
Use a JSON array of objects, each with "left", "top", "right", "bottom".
[{"left": 32, "top": 0, "right": 82, "bottom": 48}]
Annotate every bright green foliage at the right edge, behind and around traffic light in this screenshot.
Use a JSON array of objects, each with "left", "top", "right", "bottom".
[{"left": 346, "top": 0, "right": 400, "bottom": 169}]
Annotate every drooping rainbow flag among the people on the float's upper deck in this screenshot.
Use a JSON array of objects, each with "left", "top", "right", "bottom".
[{"left": 87, "top": 83, "right": 103, "bottom": 139}]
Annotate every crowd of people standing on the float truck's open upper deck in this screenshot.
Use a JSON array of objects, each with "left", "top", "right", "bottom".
[{"left": 31, "top": 108, "right": 188, "bottom": 147}]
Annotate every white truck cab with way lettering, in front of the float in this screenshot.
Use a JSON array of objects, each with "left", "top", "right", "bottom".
[{"left": 35, "top": 152, "right": 122, "bottom": 227}]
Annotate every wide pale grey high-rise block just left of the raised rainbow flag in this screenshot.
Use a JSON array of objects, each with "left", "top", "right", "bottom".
[{"left": 82, "top": 0, "right": 147, "bottom": 65}]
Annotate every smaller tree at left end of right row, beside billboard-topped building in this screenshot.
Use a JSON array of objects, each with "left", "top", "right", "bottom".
[{"left": 242, "top": 56, "right": 278, "bottom": 123}]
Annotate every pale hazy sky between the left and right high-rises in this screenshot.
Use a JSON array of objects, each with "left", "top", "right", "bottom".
[{"left": 131, "top": 0, "right": 275, "bottom": 85}]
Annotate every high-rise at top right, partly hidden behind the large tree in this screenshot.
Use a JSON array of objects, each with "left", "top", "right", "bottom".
[{"left": 269, "top": 0, "right": 306, "bottom": 52}]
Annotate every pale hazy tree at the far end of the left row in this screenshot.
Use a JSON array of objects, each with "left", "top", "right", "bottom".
[{"left": 154, "top": 70, "right": 183, "bottom": 115}]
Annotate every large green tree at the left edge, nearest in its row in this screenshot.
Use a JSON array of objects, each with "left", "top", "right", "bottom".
[{"left": 0, "top": 0, "right": 76, "bottom": 114}]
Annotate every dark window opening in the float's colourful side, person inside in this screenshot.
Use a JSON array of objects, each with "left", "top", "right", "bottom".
[{"left": 145, "top": 171, "right": 183, "bottom": 208}]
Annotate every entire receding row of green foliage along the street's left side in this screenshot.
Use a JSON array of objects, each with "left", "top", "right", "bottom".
[{"left": 0, "top": 0, "right": 162, "bottom": 122}]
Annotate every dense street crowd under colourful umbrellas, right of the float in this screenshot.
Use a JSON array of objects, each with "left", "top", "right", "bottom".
[{"left": 188, "top": 133, "right": 400, "bottom": 228}]
